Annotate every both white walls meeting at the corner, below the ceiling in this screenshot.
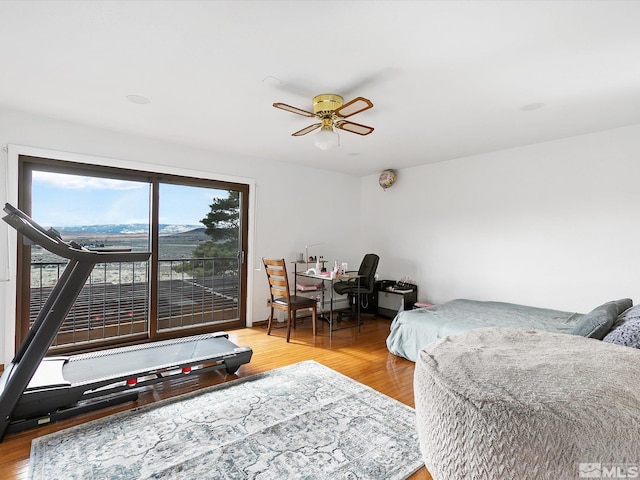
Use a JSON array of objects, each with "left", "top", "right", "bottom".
[{"left": 5, "top": 110, "right": 640, "bottom": 363}]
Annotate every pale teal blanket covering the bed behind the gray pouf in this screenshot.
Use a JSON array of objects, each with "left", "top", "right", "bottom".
[{"left": 387, "top": 299, "right": 582, "bottom": 362}]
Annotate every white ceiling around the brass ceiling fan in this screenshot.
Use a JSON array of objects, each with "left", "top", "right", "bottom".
[{"left": 0, "top": 0, "right": 640, "bottom": 175}]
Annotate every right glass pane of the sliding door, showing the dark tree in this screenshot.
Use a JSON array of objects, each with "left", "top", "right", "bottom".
[{"left": 157, "top": 183, "right": 243, "bottom": 331}]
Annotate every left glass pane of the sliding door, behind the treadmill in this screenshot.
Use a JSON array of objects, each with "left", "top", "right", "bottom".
[{"left": 27, "top": 169, "right": 151, "bottom": 347}]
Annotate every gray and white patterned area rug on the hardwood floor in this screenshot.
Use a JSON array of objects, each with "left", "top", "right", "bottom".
[{"left": 28, "top": 361, "right": 423, "bottom": 480}]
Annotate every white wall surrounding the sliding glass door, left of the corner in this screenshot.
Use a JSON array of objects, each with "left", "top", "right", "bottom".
[{"left": 0, "top": 110, "right": 362, "bottom": 364}]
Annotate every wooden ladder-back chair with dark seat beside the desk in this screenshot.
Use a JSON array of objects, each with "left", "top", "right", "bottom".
[{"left": 262, "top": 258, "right": 318, "bottom": 342}]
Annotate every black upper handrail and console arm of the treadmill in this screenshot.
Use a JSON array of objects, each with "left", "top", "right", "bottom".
[{"left": 3, "top": 203, "right": 151, "bottom": 264}]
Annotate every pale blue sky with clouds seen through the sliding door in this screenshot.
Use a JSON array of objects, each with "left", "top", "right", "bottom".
[{"left": 32, "top": 171, "right": 227, "bottom": 227}]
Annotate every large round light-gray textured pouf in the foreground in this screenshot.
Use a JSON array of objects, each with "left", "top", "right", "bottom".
[{"left": 414, "top": 328, "right": 640, "bottom": 480}]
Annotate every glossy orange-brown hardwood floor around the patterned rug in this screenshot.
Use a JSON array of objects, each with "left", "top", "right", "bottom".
[{"left": 0, "top": 319, "right": 431, "bottom": 480}]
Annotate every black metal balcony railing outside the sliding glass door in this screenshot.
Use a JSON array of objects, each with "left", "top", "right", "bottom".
[{"left": 29, "top": 257, "right": 239, "bottom": 347}]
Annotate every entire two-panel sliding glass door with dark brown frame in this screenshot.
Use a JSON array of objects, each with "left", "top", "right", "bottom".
[{"left": 17, "top": 157, "right": 248, "bottom": 350}]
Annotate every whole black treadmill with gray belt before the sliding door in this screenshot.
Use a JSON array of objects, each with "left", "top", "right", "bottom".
[{"left": 0, "top": 203, "right": 253, "bottom": 442}]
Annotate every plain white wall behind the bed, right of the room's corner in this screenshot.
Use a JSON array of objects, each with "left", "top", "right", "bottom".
[{"left": 362, "top": 125, "right": 640, "bottom": 312}]
